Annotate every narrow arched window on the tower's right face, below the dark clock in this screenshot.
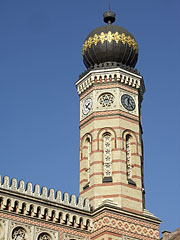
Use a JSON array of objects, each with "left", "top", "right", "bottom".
[{"left": 126, "top": 134, "right": 136, "bottom": 185}]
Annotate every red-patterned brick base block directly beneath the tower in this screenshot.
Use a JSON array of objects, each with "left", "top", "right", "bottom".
[{"left": 92, "top": 206, "right": 160, "bottom": 240}]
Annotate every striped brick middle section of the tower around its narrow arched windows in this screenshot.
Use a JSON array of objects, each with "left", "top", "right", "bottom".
[{"left": 80, "top": 112, "right": 142, "bottom": 211}]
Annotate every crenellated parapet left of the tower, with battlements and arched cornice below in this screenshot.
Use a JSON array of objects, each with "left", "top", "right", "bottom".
[{"left": 0, "top": 176, "right": 92, "bottom": 231}]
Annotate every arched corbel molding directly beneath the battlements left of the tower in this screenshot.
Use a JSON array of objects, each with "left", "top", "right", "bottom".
[{"left": 0, "top": 196, "right": 93, "bottom": 232}]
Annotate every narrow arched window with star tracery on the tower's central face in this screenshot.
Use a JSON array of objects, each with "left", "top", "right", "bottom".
[{"left": 103, "top": 133, "right": 112, "bottom": 182}]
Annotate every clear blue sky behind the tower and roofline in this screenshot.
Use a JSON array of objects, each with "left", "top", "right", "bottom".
[{"left": 0, "top": 0, "right": 180, "bottom": 236}]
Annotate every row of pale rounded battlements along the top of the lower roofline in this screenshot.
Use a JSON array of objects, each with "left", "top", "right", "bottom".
[{"left": 0, "top": 175, "right": 91, "bottom": 212}]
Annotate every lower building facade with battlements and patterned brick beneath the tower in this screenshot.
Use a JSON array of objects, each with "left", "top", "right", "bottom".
[{"left": 0, "top": 177, "right": 160, "bottom": 240}]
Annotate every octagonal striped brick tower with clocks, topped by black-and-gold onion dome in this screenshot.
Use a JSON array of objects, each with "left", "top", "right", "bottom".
[{"left": 76, "top": 10, "right": 145, "bottom": 213}]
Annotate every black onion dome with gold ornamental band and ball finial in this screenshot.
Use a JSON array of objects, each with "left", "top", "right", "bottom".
[{"left": 82, "top": 9, "right": 138, "bottom": 68}]
